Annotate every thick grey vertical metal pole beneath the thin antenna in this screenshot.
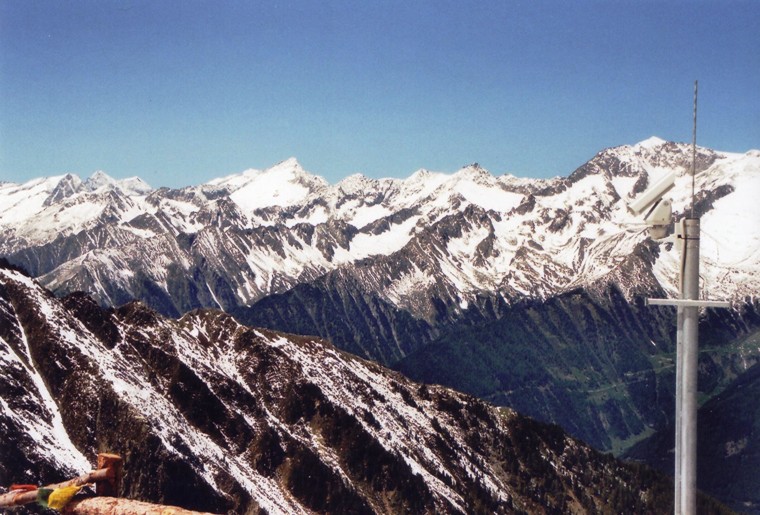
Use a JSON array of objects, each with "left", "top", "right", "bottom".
[{"left": 680, "top": 218, "right": 699, "bottom": 514}]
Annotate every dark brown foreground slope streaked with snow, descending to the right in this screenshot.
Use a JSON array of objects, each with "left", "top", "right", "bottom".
[{"left": 0, "top": 269, "right": 732, "bottom": 513}]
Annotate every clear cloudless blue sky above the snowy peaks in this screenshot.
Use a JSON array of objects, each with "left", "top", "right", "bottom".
[{"left": 0, "top": 0, "right": 760, "bottom": 187}]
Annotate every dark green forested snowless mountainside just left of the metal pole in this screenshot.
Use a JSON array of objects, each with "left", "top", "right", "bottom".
[{"left": 398, "top": 288, "right": 674, "bottom": 449}]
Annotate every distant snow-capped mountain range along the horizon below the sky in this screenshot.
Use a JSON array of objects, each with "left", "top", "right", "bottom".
[{"left": 0, "top": 138, "right": 760, "bottom": 320}]
